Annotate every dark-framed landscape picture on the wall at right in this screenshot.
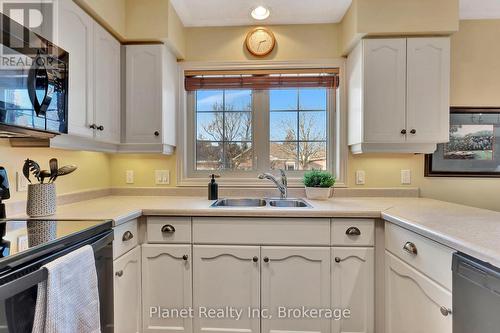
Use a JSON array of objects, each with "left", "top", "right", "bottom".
[{"left": 425, "top": 107, "right": 500, "bottom": 177}]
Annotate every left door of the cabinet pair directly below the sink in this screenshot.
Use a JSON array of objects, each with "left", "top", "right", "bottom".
[{"left": 193, "top": 245, "right": 260, "bottom": 333}]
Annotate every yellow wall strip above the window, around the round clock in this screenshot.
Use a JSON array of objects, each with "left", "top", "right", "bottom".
[{"left": 185, "top": 24, "right": 340, "bottom": 61}]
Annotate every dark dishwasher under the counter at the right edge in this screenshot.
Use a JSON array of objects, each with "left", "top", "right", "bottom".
[{"left": 453, "top": 253, "right": 500, "bottom": 333}]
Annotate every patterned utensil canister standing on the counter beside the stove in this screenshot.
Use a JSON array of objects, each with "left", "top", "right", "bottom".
[{"left": 26, "top": 183, "right": 56, "bottom": 217}]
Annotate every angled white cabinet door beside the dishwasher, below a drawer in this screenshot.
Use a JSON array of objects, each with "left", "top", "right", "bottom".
[{"left": 385, "top": 251, "right": 452, "bottom": 333}]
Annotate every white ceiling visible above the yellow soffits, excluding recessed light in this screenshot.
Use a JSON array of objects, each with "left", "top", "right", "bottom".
[{"left": 170, "top": 0, "right": 500, "bottom": 27}]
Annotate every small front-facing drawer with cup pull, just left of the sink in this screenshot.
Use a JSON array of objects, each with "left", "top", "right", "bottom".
[{"left": 147, "top": 217, "right": 191, "bottom": 243}]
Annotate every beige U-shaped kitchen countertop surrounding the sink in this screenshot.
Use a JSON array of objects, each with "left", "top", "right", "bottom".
[{"left": 15, "top": 196, "right": 500, "bottom": 267}]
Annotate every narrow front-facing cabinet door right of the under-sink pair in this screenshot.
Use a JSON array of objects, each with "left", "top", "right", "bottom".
[{"left": 332, "top": 247, "right": 375, "bottom": 333}]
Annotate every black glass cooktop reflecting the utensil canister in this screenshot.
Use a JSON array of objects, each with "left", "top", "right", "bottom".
[{"left": 0, "top": 219, "right": 112, "bottom": 272}]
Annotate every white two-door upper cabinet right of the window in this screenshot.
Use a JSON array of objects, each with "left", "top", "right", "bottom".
[{"left": 347, "top": 37, "right": 450, "bottom": 153}]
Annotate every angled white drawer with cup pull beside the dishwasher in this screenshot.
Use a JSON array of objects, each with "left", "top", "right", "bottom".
[{"left": 385, "top": 222, "right": 455, "bottom": 290}]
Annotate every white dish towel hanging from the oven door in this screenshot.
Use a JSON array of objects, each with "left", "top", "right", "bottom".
[{"left": 32, "top": 245, "right": 101, "bottom": 333}]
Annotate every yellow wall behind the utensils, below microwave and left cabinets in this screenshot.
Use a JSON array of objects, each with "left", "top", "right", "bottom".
[{"left": 0, "top": 139, "right": 111, "bottom": 201}]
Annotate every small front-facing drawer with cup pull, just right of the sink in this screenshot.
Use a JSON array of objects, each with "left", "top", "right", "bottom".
[{"left": 332, "top": 219, "right": 375, "bottom": 246}]
